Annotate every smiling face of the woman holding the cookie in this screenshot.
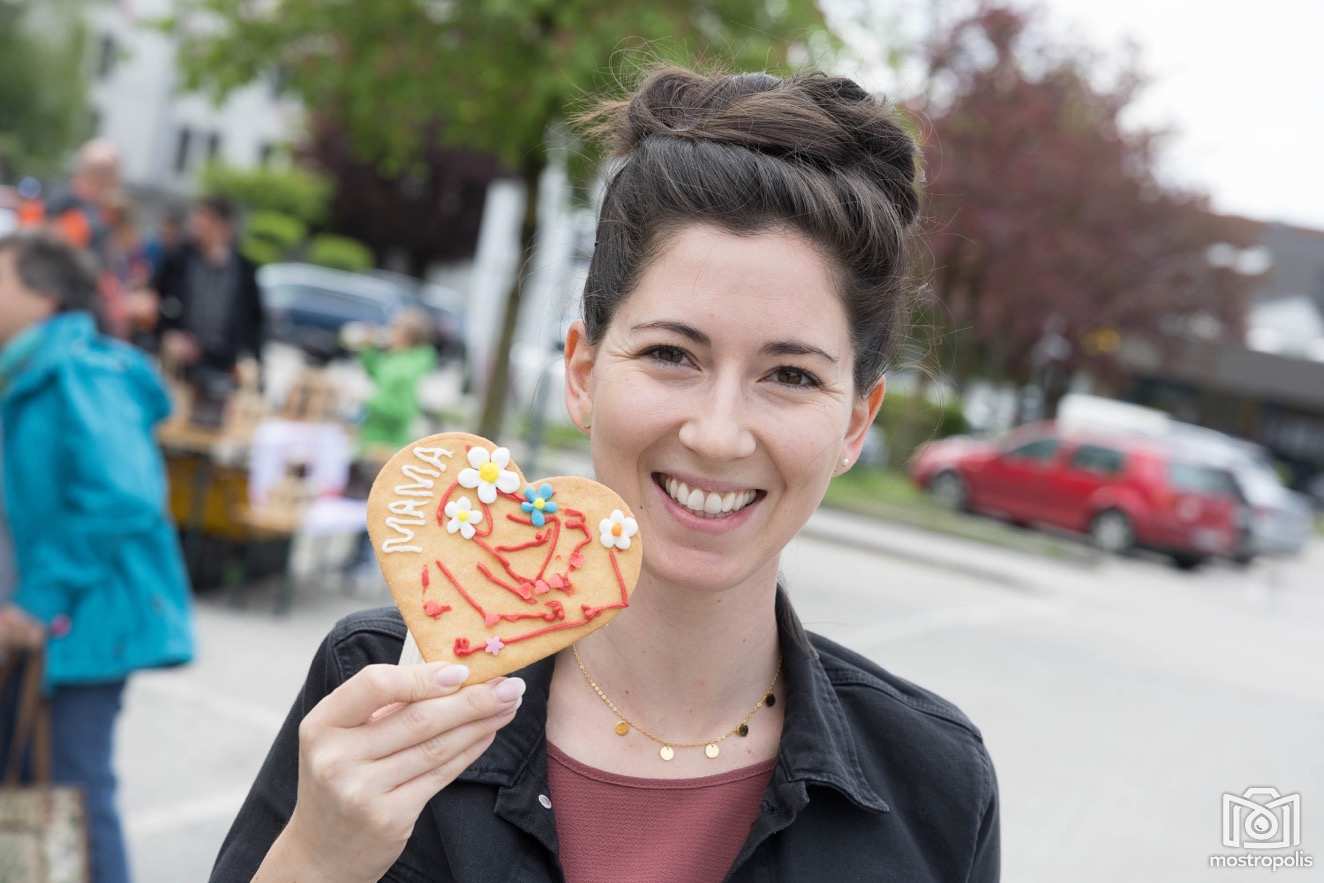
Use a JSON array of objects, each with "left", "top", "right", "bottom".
[{"left": 565, "top": 225, "right": 883, "bottom": 590}]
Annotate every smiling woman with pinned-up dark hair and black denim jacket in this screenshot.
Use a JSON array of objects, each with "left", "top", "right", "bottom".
[{"left": 213, "top": 69, "right": 1000, "bottom": 883}]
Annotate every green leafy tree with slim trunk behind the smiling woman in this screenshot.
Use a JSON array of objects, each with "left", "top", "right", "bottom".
[{"left": 171, "top": 0, "right": 821, "bottom": 438}]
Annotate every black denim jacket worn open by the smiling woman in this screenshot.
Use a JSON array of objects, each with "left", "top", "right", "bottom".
[{"left": 212, "top": 589, "right": 1000, "bottom": 883}]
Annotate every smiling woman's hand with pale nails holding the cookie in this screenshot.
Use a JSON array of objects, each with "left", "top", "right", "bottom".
[{"left": 254, "top": 663, "right": 524, "bottom": 883}]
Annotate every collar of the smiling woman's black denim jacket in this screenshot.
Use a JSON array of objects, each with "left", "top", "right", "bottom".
[{"left": 459, "top": 585, "right": 891, "bottom": 813}]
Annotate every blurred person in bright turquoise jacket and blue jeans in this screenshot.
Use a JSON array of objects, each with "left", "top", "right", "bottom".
[{"left": 0, "top": 232, "right": 193, "bottom": 883}]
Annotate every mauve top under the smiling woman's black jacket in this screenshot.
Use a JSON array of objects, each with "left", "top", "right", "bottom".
[{"left": 547, "top": 743, "right": 777, "bottom": 883}]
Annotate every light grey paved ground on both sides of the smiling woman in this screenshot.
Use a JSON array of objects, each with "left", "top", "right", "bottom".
[{"left": 119, "top": 514, "right": 1324, "bottom": 883}]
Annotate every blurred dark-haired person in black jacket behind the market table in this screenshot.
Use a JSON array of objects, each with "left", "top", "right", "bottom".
[{"left": 151, "top": 196, "right": 263, "bottom": 385}]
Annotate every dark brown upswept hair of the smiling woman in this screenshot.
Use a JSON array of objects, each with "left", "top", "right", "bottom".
[{"left": 580, "top": 68, "right": 919, "bottom": 395}]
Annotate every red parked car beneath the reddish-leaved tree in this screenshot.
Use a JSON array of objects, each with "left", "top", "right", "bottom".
[{"left": 910, "top": 422, "right": 1245, "bottom": 568}]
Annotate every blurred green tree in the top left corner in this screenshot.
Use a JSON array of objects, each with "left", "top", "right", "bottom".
[{"left": 0, "top": 0, "right": 91, "bottom": 181}]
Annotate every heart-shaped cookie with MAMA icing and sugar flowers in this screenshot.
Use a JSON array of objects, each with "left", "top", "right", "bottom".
[{"left": 368, "top": 433, "right": 643, "bottom": 683}]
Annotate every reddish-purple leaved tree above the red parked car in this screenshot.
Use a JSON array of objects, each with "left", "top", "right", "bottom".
[{"left": 911, "top": 5, "right": 1247, "bottom": 399}]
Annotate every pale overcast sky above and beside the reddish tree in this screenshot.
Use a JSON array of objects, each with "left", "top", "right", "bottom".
[{"left": 821, "top": 0, "right": 1324, "bottom": 229}]
